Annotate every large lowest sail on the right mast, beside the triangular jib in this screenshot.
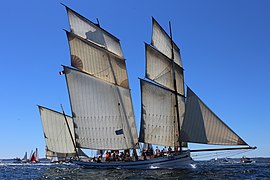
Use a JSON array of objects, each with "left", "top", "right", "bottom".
[{"left": 139, "top": 80, "right": 185, "bottom": 146}]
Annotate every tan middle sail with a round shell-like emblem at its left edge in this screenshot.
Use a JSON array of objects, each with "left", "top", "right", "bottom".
[{"left": 67, "top": 32, "right": 129, "bottom": 88}]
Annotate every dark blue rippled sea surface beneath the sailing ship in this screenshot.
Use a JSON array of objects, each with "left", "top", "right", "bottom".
[{"left": 0, "top": 158, "right": 270, "bottom": 180}]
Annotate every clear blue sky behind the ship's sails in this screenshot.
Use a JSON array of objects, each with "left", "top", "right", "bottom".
[{"left": 0, "top": 0, "right": 270, "bottom": 158}]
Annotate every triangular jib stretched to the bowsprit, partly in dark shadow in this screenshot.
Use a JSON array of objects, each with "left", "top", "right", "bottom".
[{"left": 181, "top": 88, "right": 247, "bottom": 145}]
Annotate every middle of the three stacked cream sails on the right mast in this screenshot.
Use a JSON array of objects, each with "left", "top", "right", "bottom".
[{"left": 145, "top": 44, "right": 184, "bottom": 95}]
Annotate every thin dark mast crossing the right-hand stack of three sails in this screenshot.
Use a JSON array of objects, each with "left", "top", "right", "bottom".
[{"left": 169, "top": 21, "right": 182, "bottom": 152}]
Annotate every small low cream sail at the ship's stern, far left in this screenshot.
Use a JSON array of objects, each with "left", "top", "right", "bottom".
[{"left": 38, "top": 106, "right": 75, "bottom": 153}]
